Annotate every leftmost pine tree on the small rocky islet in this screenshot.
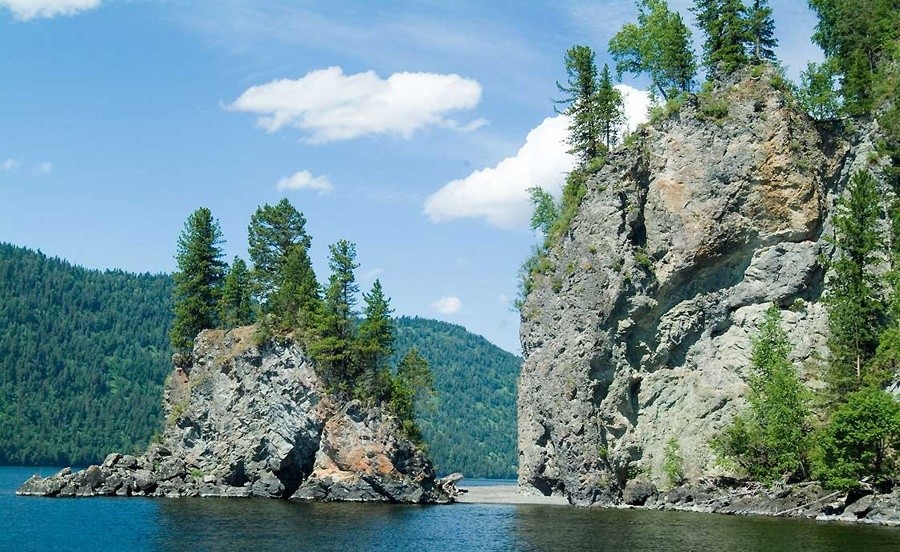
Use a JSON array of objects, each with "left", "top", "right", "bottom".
[{"left": 170, "top": 207, "right": 225, "bottom": 351}]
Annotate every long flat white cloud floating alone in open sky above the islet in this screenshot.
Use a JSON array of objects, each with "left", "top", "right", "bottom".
[{"left": 227, "top": 67, "right": 485, "bottom": 144}]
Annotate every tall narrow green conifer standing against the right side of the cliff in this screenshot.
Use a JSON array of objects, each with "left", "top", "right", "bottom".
[{"left": 825, "top": 171, "right": 883, "bottom": 398}]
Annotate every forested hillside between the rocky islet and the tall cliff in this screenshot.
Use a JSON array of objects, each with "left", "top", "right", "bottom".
[{"left": 393, "top": 317, "right": 521, "bottom": 478}]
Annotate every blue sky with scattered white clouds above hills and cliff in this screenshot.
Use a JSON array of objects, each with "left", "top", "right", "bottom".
[{"left": 0, "top": 0, "right": 821, "bottom": 352}]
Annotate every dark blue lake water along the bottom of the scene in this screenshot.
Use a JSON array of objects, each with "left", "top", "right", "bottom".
[{"left": 0, "top": 467, "right": 900, "bottom": 552}]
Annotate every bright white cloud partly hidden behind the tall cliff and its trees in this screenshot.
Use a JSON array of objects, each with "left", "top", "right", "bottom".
[{"left": 425, "top": 84, "right": 650, "bottom": 228}]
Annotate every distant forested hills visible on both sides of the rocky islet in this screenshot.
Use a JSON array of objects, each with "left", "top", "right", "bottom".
[{"left": 0, "top": 244, "right": 520, "bottom": 477}]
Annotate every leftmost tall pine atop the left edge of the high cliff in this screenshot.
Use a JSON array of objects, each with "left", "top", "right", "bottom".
[{"left": 555, "top": 46, "right": 601, "bottom": 165}]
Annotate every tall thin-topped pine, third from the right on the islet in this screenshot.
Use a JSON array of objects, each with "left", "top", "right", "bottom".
[{"left": 309, "top": 240, "right": 360, "bottom": 392}]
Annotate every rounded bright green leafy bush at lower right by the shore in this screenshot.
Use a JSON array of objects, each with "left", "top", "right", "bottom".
[{"left": 817, "top": 387, "right": 900, "bottom": 489}]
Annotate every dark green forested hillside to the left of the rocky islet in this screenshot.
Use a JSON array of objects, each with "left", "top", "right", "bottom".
[{"left": 0, "top": 244, "right": 173, "bottom": 466}]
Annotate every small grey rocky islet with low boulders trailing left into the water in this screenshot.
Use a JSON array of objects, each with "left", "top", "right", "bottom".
[{"left": 18, "top": 327, "right": 448, "bottom": 503}]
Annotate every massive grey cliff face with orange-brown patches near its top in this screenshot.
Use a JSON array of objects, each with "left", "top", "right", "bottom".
[{"left": 518, "top": 69, "right": 869, "bottom": 504}]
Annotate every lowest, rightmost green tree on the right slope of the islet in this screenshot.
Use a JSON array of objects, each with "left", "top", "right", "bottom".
[{"left": 388, "top": 347, "right": 434, "bottom": 444}]
